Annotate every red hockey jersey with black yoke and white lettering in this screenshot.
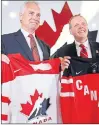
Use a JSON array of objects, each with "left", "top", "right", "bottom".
[{"left": 60, "top": 58, "right": 99, "bottom": 124}]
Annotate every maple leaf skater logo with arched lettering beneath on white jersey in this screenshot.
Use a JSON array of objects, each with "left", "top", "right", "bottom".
[{"left": 20, "top": 90, "right": 52, "bottom": 123}]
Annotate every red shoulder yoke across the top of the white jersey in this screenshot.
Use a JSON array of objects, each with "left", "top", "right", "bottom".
[{"left": 1, "top": 54, "right": 60, "bottom": 84}]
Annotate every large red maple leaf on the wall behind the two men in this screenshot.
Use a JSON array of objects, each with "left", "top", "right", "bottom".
[{"left": 36, "top": 2, "right": 72, "bottom": 47}]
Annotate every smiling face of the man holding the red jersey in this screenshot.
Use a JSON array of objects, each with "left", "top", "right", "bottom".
[{"left": 70, "top": 16, "right": 88, "bottom": 39}]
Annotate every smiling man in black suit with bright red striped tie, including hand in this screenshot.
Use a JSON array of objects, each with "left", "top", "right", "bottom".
[{"left": 54, "top": 15, "right": 99, "bottom": 71}]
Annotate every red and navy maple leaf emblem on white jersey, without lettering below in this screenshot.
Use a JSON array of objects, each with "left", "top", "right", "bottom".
[{"left": 20, "top": 90, "right": 50, "bottom": 120}]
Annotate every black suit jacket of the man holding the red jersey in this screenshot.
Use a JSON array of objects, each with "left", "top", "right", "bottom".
[{"left": 53, "top": 40, "right": 99, "bottom": 58}]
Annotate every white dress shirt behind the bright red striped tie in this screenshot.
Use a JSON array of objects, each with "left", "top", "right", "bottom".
[{"left": 75, "top": 40, "right": 92, "bottom": 58}]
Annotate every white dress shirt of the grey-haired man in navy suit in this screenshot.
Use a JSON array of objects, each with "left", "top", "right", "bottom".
[{"left": 21, "top": 28, "right": 43, "bottom": 61}]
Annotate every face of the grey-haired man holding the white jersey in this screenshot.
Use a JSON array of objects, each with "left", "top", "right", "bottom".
[{"left": 20, "top": 3, "right": 40, "bottom": 31}]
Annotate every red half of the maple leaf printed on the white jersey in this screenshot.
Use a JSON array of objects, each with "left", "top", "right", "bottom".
[{"left": 20, "top": 90, "right": 42, "bottom": 116}]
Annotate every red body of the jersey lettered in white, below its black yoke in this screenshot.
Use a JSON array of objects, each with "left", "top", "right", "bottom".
[{"left": 60, "top": 74, "right": 99, "bottom": 124}]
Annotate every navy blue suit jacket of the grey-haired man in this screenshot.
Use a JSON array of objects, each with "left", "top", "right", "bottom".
[{"left": 1, "top": 30, "right": 50, "bottom": 61}]
